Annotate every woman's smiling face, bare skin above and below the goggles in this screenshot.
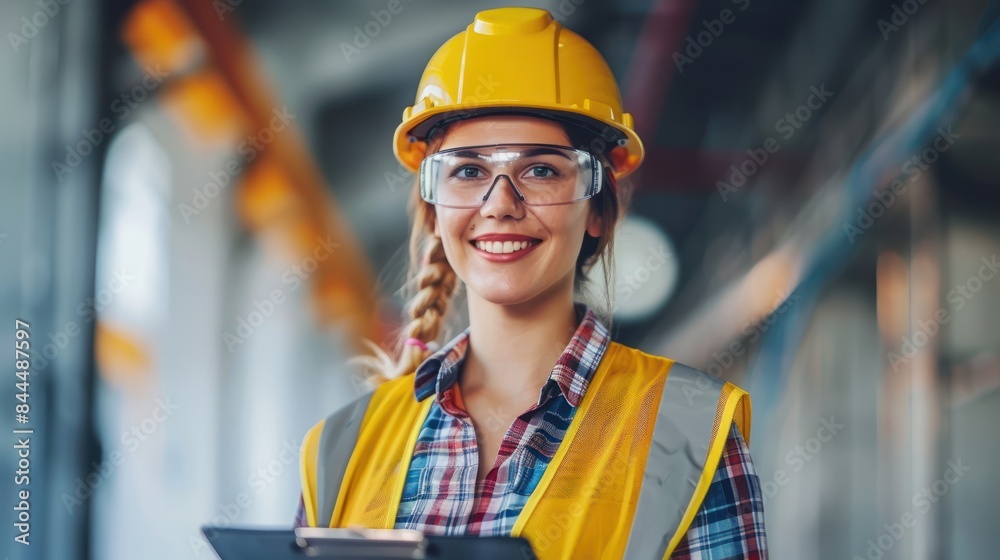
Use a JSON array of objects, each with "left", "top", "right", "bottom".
[{"left": 434, "top": 115, "right": 602, "bottom": 305}]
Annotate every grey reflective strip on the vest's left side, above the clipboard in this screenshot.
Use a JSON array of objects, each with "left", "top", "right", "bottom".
[{"left": 316, "top": 391, "right": 374, "bottom": 527}]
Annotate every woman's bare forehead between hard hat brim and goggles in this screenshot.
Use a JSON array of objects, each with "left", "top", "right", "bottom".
[{"left": 438, "top": 115, "right": 570, "bottom": 150}]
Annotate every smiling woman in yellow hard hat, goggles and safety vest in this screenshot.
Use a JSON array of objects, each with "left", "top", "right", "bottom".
[{"left": 296, "top": 8, "right": 766, "bottom": 558}]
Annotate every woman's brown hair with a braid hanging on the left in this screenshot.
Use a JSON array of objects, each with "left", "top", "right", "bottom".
[{"left": 350, "top": 119, "right": 631, "bottom": 385}]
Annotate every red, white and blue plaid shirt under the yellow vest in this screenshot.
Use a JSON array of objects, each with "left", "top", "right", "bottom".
[{"left": 295, "top": 303, "right": 767, "bottom": 560}]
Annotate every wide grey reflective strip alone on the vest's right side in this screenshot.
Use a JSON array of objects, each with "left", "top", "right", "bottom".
[{"left": 625, "top": 362, "right": 726, "bottom": 560}]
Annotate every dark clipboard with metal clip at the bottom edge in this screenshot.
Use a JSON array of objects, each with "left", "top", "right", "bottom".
[{"left": 201, "top": 525, "right": 535, "bottom": 560}]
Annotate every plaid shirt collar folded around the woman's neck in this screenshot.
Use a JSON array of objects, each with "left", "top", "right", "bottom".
[{"left": 413, "top": 302, "right": 611, "bottom": 407}]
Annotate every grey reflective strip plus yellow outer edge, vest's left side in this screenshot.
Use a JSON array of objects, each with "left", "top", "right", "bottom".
[{"left": 299, "top": 391, "right": 374, "bottom": 527}]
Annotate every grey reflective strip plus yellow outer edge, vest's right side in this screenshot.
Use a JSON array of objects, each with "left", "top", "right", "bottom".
[{"left": 625, "top": 362, "right": 750, "bottom": 559}]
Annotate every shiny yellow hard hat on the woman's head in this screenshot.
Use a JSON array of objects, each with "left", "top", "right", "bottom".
[{"left": 393, "top": 8, "right": 644, "bottom": 178}]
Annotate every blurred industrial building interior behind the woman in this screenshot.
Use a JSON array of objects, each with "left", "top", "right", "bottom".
[{"left": 0, "top": 0, "right": 1000, "bottom": 560}]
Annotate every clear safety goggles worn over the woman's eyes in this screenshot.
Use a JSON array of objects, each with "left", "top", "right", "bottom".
[{"left": 420, "top": 144, "right": 604, "bottom": 208}]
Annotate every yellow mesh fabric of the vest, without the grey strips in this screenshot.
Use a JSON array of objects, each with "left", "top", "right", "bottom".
[{"left": 301, "top": 343, "right": 750, "bottom": 559}]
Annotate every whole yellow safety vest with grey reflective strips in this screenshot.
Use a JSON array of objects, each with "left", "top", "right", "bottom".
[{"left": 300, "top": 342, "right": 751, "bottom": 560}]
